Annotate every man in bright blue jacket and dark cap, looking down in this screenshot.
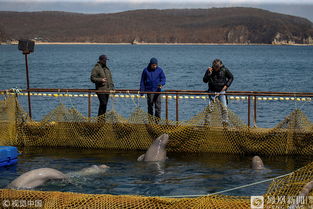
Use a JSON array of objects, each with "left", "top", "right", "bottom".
[{"left": 140, "top": 57, "right": 166, "bottom": 118}]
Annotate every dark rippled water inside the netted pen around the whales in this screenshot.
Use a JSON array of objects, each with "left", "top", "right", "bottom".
[{"left": 0, "top": 148, "right": 313, "bottom": 196}]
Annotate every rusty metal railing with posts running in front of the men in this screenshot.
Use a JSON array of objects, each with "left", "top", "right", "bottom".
[{"left": 0, "top": 88, "right": 313, "bottom": 127}]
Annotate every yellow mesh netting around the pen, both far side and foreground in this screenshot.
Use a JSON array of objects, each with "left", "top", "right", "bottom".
[{"left": 0, "top": 96, "right": 313, "bottom": 208}]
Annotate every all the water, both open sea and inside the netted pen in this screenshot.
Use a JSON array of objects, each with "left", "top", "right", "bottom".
[{"left": 0, "top": 45, "right": 313, "bottom": 196}]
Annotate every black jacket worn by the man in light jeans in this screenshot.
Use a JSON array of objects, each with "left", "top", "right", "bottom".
[{"left": 203, "top": 65, "right": 234, "bottom": 92}]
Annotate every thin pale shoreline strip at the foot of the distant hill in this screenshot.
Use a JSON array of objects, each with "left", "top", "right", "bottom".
[{"left": 0, "top": 41, "right": 313, "bottom": 46}]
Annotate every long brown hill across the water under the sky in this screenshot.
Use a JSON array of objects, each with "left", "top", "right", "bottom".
[{"left": 0, "top": 7, "right": 313, "bottom": 44}]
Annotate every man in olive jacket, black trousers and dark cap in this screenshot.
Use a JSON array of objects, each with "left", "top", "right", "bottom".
[{"left": 90, "top": 55, "right": 114, "bottom": 116}]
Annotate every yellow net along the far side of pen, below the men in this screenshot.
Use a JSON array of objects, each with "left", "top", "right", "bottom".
[{"left": 0, "top": 94, "right": 313, "bottom": 155}]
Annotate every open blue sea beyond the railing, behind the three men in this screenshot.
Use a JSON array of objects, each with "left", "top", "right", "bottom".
[{"left": 0, "top": 45, "right": 313, "bottom": 128}]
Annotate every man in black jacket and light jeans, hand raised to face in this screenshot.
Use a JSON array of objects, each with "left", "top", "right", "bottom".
[{"left": 203, "top": 59, "right": 234, "bottom": 124}]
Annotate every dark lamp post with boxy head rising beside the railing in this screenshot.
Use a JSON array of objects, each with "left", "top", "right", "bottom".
[{"left": 18, "top": 40, "right": 35, "bottom": 119}]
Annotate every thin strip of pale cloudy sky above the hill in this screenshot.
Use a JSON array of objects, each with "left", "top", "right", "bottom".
[{"left": 0, "top": 0, "right": 313, "bottom": 22}]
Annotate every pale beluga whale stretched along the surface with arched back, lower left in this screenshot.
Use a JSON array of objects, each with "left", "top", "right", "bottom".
[{"left": 7, "top": 165, "right": 109, "bottom": 189}]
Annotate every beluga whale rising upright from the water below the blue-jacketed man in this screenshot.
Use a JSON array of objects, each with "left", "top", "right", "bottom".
[{"left": 137, "top": 134, "right": 169, "bottom": 162}]
